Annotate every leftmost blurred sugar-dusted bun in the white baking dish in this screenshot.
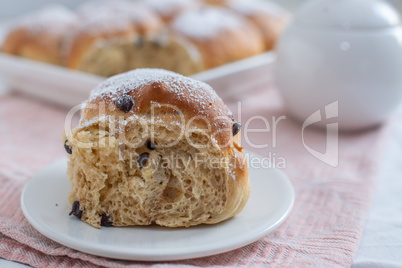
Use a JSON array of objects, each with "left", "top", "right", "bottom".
[{"left": 2, "top": 6, "right": 77, "bottom": 65}]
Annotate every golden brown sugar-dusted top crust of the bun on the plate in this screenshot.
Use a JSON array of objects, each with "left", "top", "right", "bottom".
[{"left": 81, "top": 69, "right": 233, "bottom": 150}]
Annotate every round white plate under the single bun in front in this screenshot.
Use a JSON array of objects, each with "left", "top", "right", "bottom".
[{"left": 21, "top": 155, "right": 294, "bottom": 261}]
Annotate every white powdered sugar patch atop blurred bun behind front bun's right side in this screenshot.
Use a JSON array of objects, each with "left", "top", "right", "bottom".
[{"left": 172, "top": 7, "right": 245, "bottom": 38}]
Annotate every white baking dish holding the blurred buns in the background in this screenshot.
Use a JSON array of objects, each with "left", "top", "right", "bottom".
[{"left": 0, "top": 52, "right": 275, "bottom": 107}]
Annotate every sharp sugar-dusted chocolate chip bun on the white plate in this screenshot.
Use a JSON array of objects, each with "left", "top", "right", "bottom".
[{"left": 64, "top": 69, "right": 250, "bottom": 228}]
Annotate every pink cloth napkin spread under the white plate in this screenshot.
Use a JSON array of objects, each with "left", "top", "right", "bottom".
[{"left": 0, "top": 80, "right": 386, "bottom": 267}]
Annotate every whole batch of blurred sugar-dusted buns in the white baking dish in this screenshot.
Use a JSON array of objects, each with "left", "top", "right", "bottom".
[{"left": 2, "top": 0, "right": 288, "bottom": 77}]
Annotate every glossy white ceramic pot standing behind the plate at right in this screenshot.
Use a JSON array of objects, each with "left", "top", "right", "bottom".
[{"left": 276, "top": 0, "right": 402, "bottom": 130}]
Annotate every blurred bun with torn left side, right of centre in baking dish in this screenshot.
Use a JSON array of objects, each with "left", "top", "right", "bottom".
[{"left": 125, "top": 7, "right": 264, "bottom": 75}]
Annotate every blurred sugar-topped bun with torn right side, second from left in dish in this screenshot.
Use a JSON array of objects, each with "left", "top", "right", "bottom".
[{"left": 66, "top": 0, "right": 163, "bottom": 76}]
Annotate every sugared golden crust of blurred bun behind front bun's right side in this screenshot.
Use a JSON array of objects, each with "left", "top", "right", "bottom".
[{"left": 172, "top": 7, "right": 264, "bottom": 69}]
